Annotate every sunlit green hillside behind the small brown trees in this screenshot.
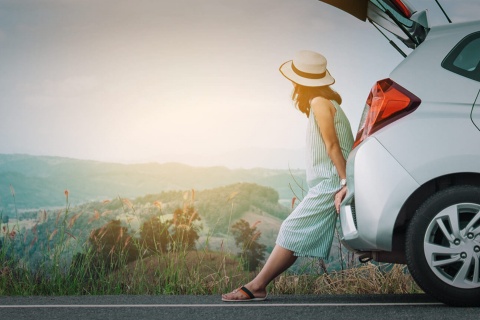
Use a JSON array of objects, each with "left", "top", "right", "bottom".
[{"left": 0, "top": 183, "right": 291, "bottom": 269}]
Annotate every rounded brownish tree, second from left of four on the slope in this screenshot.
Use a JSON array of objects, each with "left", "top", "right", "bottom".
[{"left": 140, "top": 216, "right": 171, "bottom": 253}]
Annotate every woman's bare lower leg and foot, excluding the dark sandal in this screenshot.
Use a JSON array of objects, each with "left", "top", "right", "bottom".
[{"left": 222, "top": 245, "right": 297, "bottom": 300}]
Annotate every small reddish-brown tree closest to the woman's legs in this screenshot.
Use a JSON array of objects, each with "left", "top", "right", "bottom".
[{"left": 231, "top": 219, "right": 266, "bottom": 271}]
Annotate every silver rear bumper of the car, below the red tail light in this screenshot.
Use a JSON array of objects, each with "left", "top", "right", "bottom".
[{"left": 340, "top": 137, "right": 419, "bottom": 251}]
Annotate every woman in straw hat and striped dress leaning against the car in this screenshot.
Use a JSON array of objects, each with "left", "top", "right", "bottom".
[{"left": 222, "top": 51, "right": 353, "bottom": 301}]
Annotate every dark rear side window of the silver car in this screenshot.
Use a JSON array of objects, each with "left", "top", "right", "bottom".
[{"left": 442, "top": 32, "right": 480, "bottom": 81}]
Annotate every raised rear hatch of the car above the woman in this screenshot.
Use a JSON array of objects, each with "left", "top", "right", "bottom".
[{"left": 319, "top": 0, "right": 429, "bottom": 50}]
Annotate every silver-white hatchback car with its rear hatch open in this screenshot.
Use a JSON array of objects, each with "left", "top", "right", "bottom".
[{"left": 321, "top": 0, "right": 480, "bottom": 306}]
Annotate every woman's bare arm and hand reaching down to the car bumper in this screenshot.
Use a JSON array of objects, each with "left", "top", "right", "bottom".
[{"left": 311, "top": 97, "right": 347, "bottom": 213}]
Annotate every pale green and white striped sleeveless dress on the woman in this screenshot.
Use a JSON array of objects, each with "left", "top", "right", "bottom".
[{"left": 276, "top": 100, "right": 353, "bottom": 259}]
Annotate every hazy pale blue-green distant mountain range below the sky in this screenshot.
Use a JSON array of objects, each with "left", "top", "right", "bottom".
[{"left": 0, "top": 154, "right": 304, "bottom": 211}]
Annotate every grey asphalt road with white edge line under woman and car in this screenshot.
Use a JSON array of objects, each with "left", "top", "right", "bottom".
[{"left": 0, "top": 295, "right": 474, "bottom": 320}]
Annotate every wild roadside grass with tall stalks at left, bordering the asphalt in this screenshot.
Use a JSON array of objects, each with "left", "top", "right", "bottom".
[{"left": 0, "top": 192, "right": 422, "bottom": 296}]
